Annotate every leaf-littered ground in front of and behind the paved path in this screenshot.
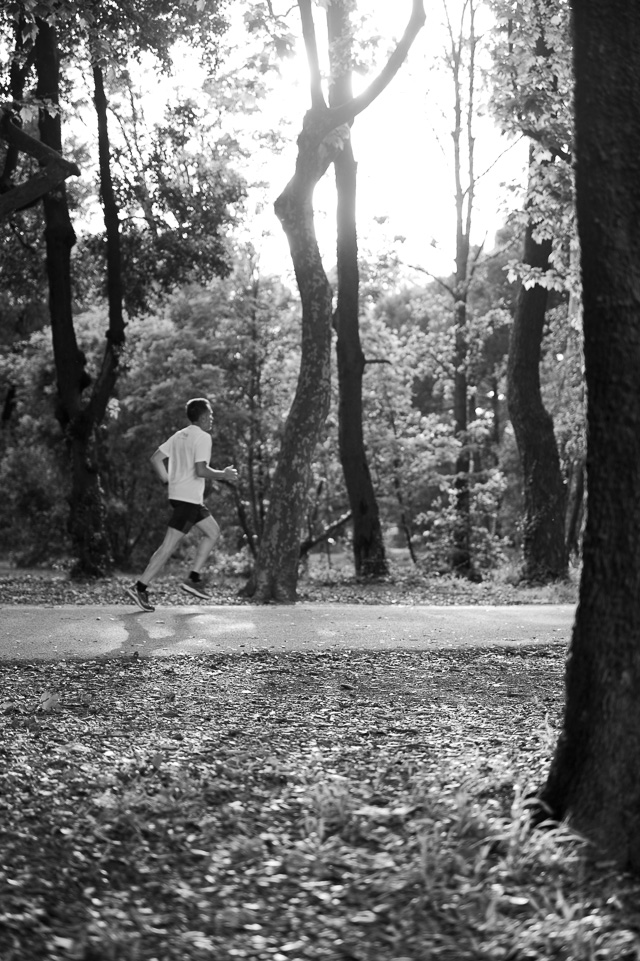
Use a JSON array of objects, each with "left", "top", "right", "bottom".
[{"left": 5, "top": 572, "right": 640, "bottom": 961}]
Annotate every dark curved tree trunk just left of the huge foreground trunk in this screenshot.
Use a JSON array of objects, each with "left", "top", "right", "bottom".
[{"left": 507, "top": 205, "right": 567, "bottom": 583}]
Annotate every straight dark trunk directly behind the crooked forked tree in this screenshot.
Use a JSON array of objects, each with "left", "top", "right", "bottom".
[{"left": 327, "top": 3, "right": 389, "bottom": 577}]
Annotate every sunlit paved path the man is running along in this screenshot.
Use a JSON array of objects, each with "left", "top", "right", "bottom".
[{"left": 0, "top": 604, "right": 575, "bottom": 661}]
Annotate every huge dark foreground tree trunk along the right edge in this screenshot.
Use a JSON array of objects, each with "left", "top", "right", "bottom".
[{"left": 541, "top": 0, "right": 640, "bottom": 872}]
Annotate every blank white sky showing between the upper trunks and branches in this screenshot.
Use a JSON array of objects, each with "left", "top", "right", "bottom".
[{"left": 232, "top": 0, "right": 527, "bottom": 282}]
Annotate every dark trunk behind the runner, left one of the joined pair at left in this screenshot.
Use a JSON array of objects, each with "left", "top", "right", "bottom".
[{"left": 35, "top": 20, "right": 110, "bottom": 576}]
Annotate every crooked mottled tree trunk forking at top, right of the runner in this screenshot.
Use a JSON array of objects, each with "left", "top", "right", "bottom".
[{"left": 247, "top": 0, "right": 425, "bottom": 602}]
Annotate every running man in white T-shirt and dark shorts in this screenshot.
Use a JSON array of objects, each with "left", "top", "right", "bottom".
[{"left": 126, "top": 397, "right": 238, "bottom": 611}]
